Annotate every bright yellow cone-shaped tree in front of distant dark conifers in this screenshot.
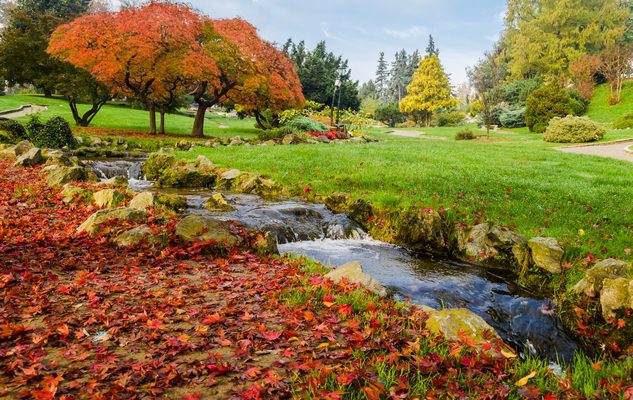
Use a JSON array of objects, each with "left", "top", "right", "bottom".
[{"left": 400, "top": 55, "right": 457, "bottom": 126}]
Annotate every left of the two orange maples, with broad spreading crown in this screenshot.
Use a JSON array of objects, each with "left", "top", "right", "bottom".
[{"left": 48, "top": 3, "right": 212, "bottom": 133}]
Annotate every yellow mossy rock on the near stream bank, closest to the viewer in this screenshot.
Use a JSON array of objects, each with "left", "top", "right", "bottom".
[{"left": 426, "top": 308, "right": 499, "bottom": 342}]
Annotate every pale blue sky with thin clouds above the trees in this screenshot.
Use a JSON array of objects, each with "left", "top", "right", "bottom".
[{"left": 115, "top": 0, "right": 505, "bottom": 85}]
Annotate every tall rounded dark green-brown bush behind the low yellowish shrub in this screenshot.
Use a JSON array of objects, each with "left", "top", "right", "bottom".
[{"left": 525, "top": 83, "right": 574, "bottom": 133}]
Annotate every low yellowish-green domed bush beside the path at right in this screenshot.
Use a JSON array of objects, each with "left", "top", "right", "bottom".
[{"left": 543, "top": 115, "right": 606, "bottom": 143}]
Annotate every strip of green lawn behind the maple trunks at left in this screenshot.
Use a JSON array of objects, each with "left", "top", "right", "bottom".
[{"left": 0, "top": 95, "right": 257, "bottom": 137}]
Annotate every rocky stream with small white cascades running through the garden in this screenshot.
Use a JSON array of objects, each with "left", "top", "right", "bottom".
[{"left": 86, "top": 160, "right": 580, "bottom": 362}]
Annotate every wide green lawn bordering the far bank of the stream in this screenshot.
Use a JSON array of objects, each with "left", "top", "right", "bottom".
[{"left": 179, "top": 128, "right": 633, "bottom": 258}]
